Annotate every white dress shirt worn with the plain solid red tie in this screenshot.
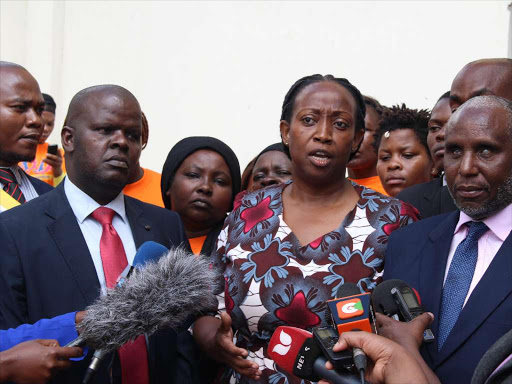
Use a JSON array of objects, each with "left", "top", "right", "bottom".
[{"left": 64, "top": 177, "right": 136, "bottom": 293}]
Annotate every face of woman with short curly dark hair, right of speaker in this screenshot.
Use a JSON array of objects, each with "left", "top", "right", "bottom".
[{"left": 377, "top": 129, "right": 432, "bottom": 196}]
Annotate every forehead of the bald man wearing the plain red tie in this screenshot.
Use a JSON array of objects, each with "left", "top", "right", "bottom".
[{"left": 81, "top": 94, "right": 142, "bottom": 128}]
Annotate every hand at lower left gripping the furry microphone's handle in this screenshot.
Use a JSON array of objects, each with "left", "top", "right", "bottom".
[{"left": 0, "top": 340, "right": 82, "bottom": 384}]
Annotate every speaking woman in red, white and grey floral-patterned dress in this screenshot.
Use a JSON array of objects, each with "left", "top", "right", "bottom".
[{"left": 194, "top": 75, "right": 416, "bottom": 384}]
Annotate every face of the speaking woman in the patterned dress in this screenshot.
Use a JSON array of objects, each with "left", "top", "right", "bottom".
[{"left": 281, "top": 81, "right": 363, "bottom": 183}]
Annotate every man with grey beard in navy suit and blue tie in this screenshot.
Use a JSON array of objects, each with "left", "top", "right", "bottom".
[{"left": 384, "top": 96, "right": 512, "bottom": 384}]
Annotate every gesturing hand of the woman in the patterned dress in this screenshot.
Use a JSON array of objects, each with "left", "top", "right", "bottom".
[{"left": 209, "top": 312, "right": 261, "bottom": 380}]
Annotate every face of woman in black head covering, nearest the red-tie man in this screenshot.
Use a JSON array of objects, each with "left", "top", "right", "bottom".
[{"left": 166, "top": 149, "right": 232, "bottom": 231}]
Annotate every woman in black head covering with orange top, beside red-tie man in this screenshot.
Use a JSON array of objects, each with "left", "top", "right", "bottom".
[{"left": 161, "top": 136, "right": 240, "bottom": 255}]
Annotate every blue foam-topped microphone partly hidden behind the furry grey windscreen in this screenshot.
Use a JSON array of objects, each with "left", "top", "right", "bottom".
[{"left": 82, "top": 241, "right": 169, "bottom": 384}]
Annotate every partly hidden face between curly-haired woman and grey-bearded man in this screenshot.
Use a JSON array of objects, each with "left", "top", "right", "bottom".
[{"left": 427, "top": 97, "right": 452, "bottom": 173}]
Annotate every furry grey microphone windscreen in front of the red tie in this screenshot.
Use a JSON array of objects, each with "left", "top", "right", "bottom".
[{"left": 78, "top": 248, "right": 216, "bottom": 351}]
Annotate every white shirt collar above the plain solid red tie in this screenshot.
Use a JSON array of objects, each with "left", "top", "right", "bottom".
[{"left": 64, "top": 177, "right": 128, "bottom": 224}]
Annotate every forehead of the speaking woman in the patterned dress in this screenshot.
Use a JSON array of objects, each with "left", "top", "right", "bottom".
[{"left": 294, "top": 81, "right": 356, "bottom": 113}]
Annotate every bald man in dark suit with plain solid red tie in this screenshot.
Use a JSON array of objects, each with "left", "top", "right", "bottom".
[{"left": 0, "top": 85, "right": 191, "bottom": 383}]
